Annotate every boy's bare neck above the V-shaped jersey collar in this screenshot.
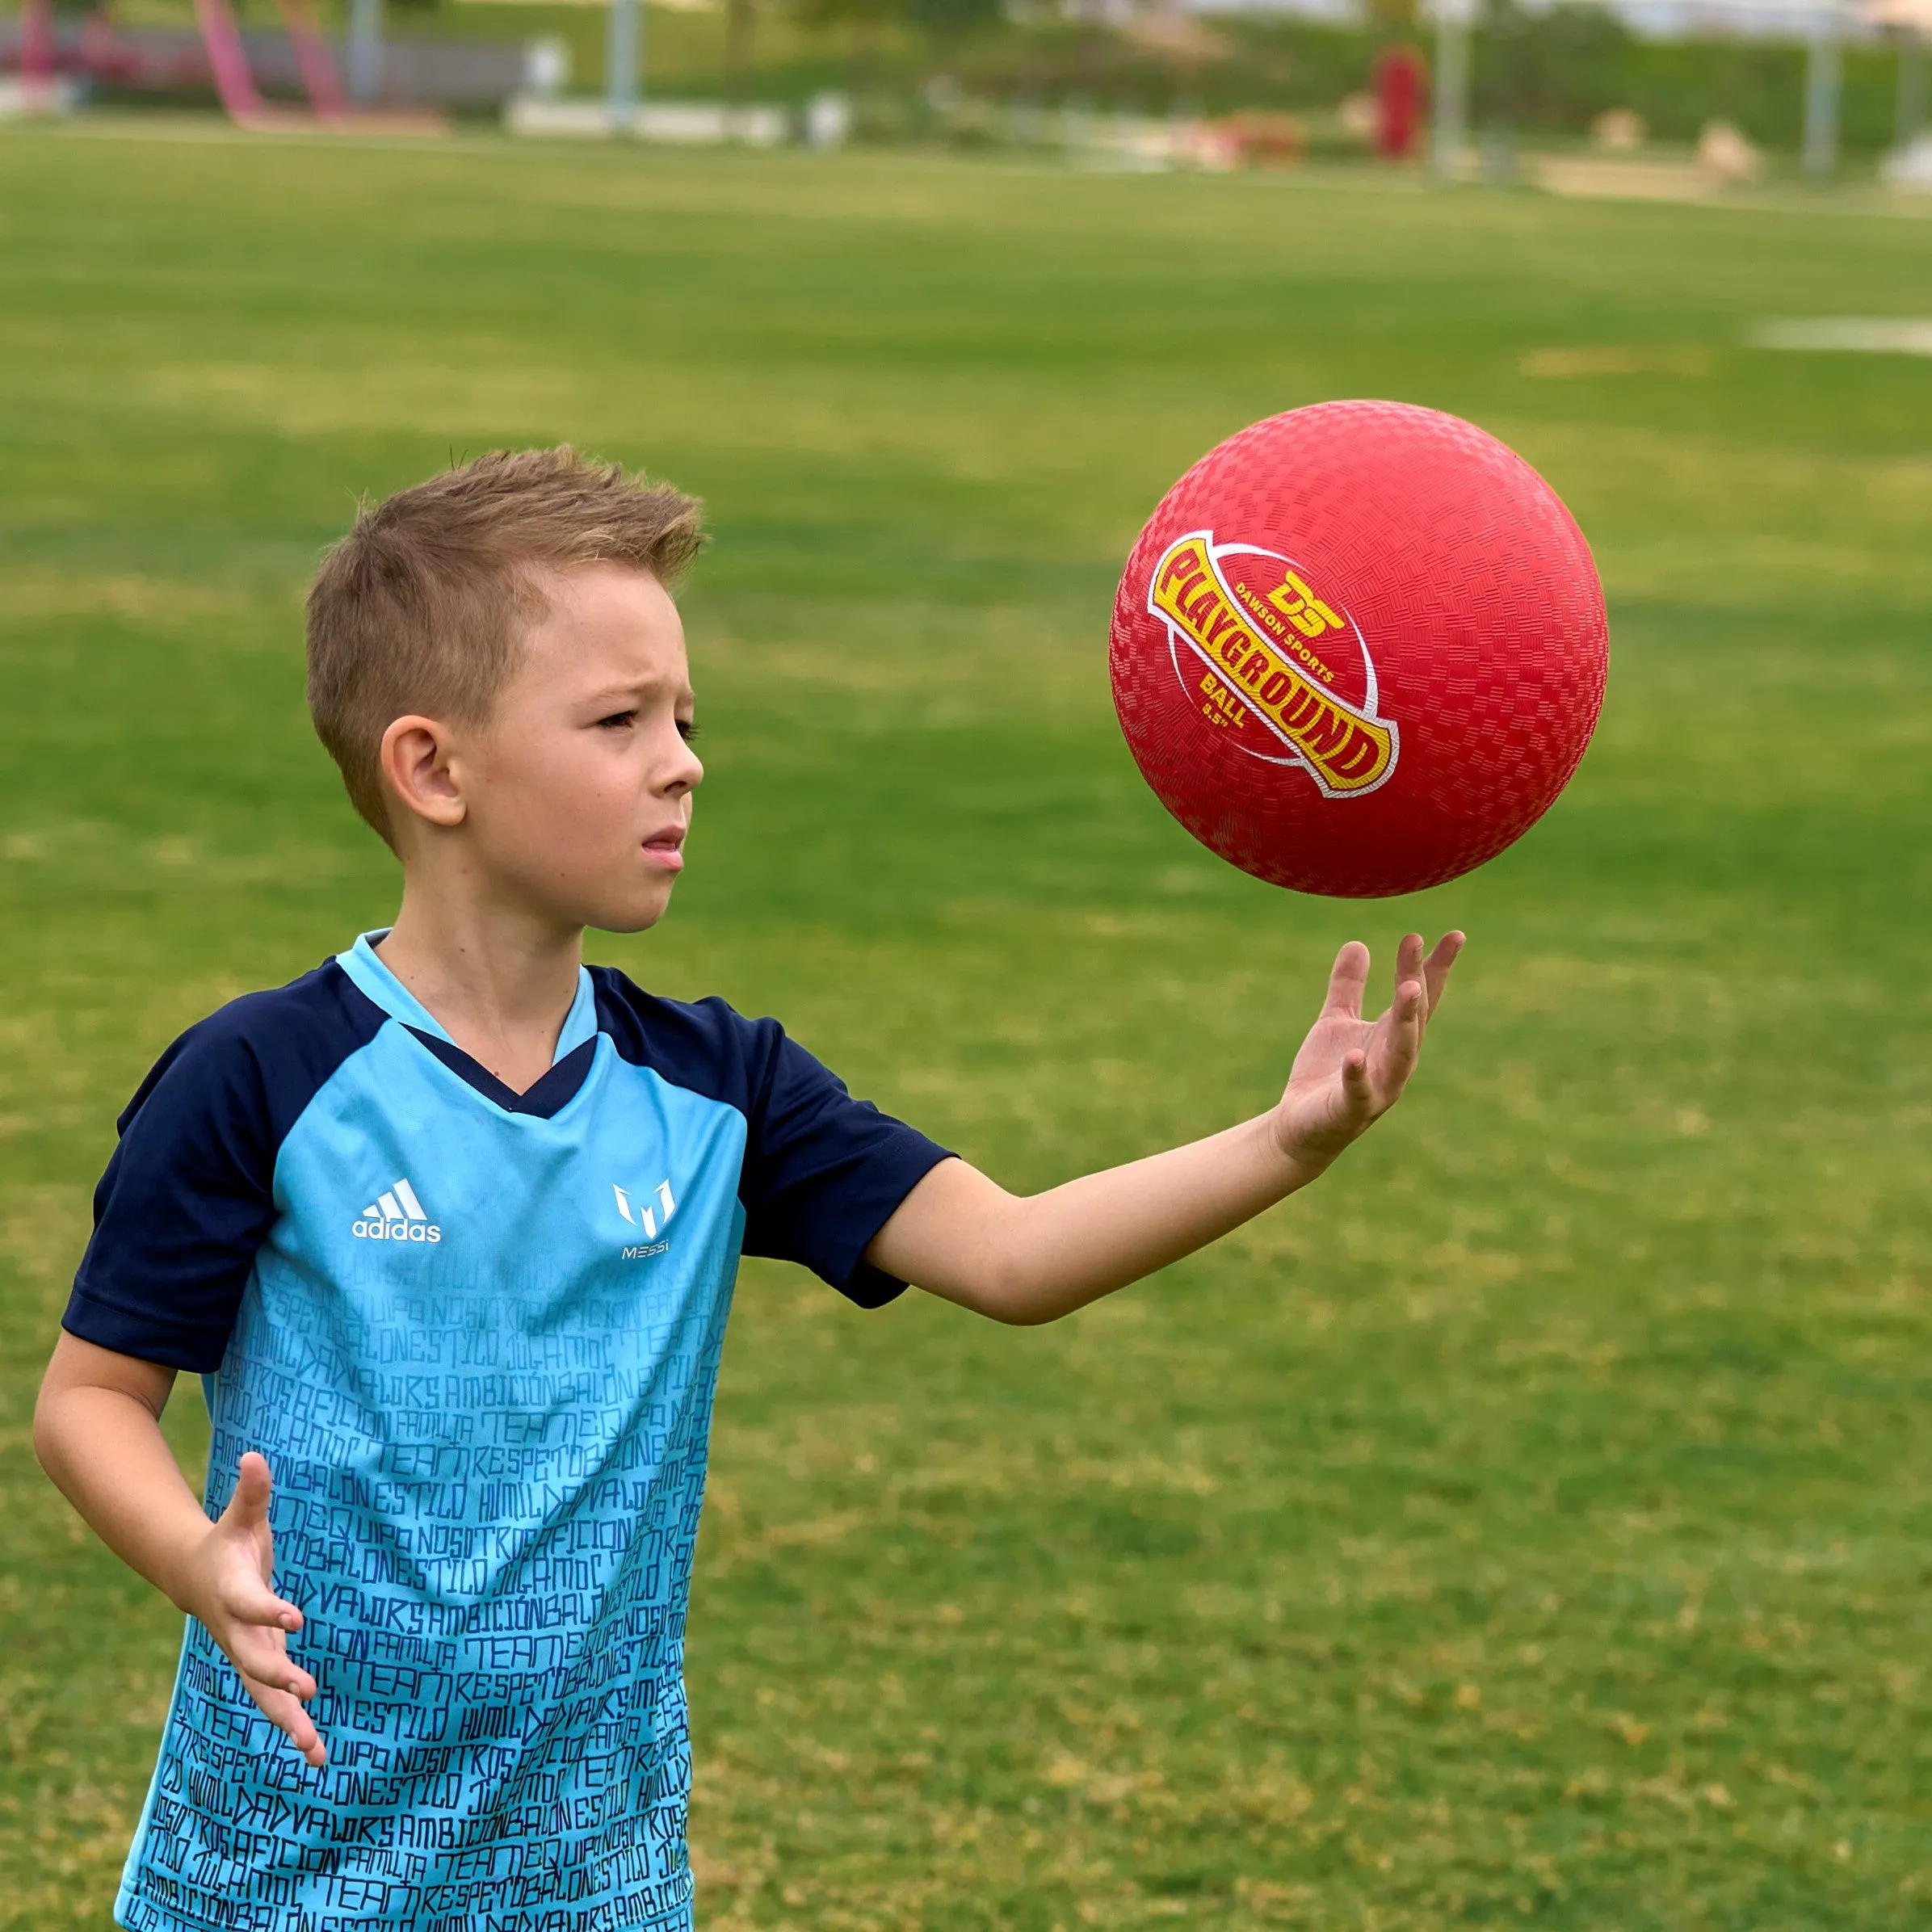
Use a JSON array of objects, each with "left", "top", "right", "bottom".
[{"left": 375, "top": 879, "right": 583, "bottom": 1094}]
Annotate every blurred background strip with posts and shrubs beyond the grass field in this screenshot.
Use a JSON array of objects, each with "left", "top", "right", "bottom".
[{"left": 11, "top": 0, "right": 1932, "bottom": 181}]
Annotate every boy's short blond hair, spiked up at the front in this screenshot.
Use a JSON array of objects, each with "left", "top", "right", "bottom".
[{"left": 297, "top": 443, "right": 704, "bottom": 842}]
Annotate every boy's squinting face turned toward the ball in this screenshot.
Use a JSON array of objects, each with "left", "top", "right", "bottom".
[{"left": 447, "top": 564, "right": 705, "bottom": 933}]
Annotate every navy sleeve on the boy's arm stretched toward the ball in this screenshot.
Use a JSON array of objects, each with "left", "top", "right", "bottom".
[{"left": 591, "top": 966, "right": 952, "bottom": 1308}]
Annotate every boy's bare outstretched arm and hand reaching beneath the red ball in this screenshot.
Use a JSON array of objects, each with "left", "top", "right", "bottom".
[{"left": 866, "top": 933, "right": 1463, "bottom": 1324}]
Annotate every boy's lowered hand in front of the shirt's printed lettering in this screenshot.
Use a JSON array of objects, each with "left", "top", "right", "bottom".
[{"left": 178, "top": 1449, "right": 329, "bottom": 1770}]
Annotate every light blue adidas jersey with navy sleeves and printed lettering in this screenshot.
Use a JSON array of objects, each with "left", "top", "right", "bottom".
[{"left": 64, "top": 935, "right": 945, "bottom": 1932}]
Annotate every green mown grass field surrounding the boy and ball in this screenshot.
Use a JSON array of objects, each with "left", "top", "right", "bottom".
[{"left": 0, "top": 132, "right": 1932, "bottom": 1932}]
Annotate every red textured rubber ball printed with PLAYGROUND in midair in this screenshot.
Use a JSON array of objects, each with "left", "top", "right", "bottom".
[{"left": 1111, "top": 402, "right": 1610, "bottom": 898}]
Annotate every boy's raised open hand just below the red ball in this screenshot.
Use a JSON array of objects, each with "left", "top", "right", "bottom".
[{"left": 1270, "top": 933, "right": 1463, "bottom": 1178}]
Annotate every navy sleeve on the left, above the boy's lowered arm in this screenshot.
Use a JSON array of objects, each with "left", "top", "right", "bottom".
[{"left": 60, "top": 962, "right": 383, "bottom": 1374}]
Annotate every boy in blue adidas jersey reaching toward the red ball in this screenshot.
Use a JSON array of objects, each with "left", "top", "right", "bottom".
[{"left": 35, "top": 448, "right": 1460, "bottom": 1932}]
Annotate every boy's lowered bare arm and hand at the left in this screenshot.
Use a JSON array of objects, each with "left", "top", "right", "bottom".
[{"left": 33, "top": 1333, "right": 325, "bottom": 1766}]
